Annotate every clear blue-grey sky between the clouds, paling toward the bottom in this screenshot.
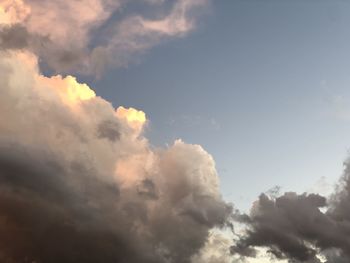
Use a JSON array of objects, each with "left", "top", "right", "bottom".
[{"left": 87, "top": 0, "right": 350, "bottom": 209}]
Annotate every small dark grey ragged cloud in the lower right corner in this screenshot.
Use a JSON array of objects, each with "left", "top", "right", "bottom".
[{"left": 231, "top": 162, "right": 350, "bottom": 263}]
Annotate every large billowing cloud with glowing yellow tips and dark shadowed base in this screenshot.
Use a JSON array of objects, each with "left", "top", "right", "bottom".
[{"left": 0, "top": 51, "right": 231, "bottom": 263}]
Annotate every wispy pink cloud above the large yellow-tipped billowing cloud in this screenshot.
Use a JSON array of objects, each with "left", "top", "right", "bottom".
[{"left": 0, "top": 0, "right": 209, "bottom": 74}]
